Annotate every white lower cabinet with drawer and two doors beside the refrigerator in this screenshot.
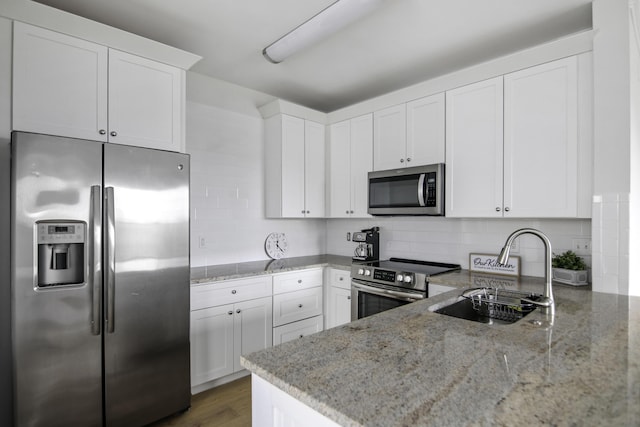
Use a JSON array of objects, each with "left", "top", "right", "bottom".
[{"left": 191, "top": 276, "right": 273, "bottom": 387}]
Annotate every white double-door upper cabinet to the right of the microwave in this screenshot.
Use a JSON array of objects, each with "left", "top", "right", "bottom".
[{"left": 446, "top": 56, "right": 591, "bottom": 218}]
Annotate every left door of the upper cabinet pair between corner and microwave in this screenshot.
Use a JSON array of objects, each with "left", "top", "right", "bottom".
[{"left": 327, "top": 120, "right": 351, "bottom": 218}]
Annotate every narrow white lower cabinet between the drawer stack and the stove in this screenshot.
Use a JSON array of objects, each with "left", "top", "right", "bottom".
[{"left": 325, "top": 268, "right": 351, "bottom": 329}]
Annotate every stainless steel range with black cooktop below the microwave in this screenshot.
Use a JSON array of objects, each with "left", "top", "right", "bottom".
[{"left": 351, "top": 258, "right": 460, "bottom": 320}]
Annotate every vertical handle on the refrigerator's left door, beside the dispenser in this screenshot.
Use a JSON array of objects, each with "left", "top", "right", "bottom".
[{"left": 89, "top": 185, "right": 102, "bottom": 335}]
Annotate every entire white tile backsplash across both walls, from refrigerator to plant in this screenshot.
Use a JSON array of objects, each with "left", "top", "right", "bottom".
[{"left": 187, "top": 102, "right": 591, "bottom": 276}]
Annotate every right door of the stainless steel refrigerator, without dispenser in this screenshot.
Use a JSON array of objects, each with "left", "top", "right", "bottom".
[{"left": 104, "top": 144, "right": 191, "bottom": 426}]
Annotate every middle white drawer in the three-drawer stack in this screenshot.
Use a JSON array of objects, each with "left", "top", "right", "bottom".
[{"left": 273, "top": 287, "right": 322, "bottom": 326}]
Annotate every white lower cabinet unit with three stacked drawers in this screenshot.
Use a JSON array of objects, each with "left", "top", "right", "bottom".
[{"left": 273, "top": 268, "right": 323, "bottom": 345}]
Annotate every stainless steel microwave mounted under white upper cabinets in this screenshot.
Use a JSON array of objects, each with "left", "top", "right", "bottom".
[{"left": 367, "top": 163, "right": 444, "bottom": 216}]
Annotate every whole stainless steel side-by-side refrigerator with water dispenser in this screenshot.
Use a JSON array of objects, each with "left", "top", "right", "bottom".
[{"left": 11, "top": 132, "right": 191, "bottom": 426}]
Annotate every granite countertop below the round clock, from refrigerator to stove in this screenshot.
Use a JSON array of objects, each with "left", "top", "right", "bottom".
[{"left": 191, "top": 255, "right": 351, "bottom": 285}]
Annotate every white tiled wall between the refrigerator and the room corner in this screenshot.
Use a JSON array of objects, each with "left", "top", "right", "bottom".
[{"left": 186, "top": 95, "right": 326, "bottom": 266}]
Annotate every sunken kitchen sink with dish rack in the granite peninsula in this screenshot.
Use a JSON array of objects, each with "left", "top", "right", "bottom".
[{"left": 429, "top": 288, "right": 540, "bottom": 324}]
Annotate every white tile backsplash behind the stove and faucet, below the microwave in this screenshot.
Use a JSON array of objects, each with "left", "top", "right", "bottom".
[{"left": 327, "top": 217, "right": 591, "bottom": 276}]
